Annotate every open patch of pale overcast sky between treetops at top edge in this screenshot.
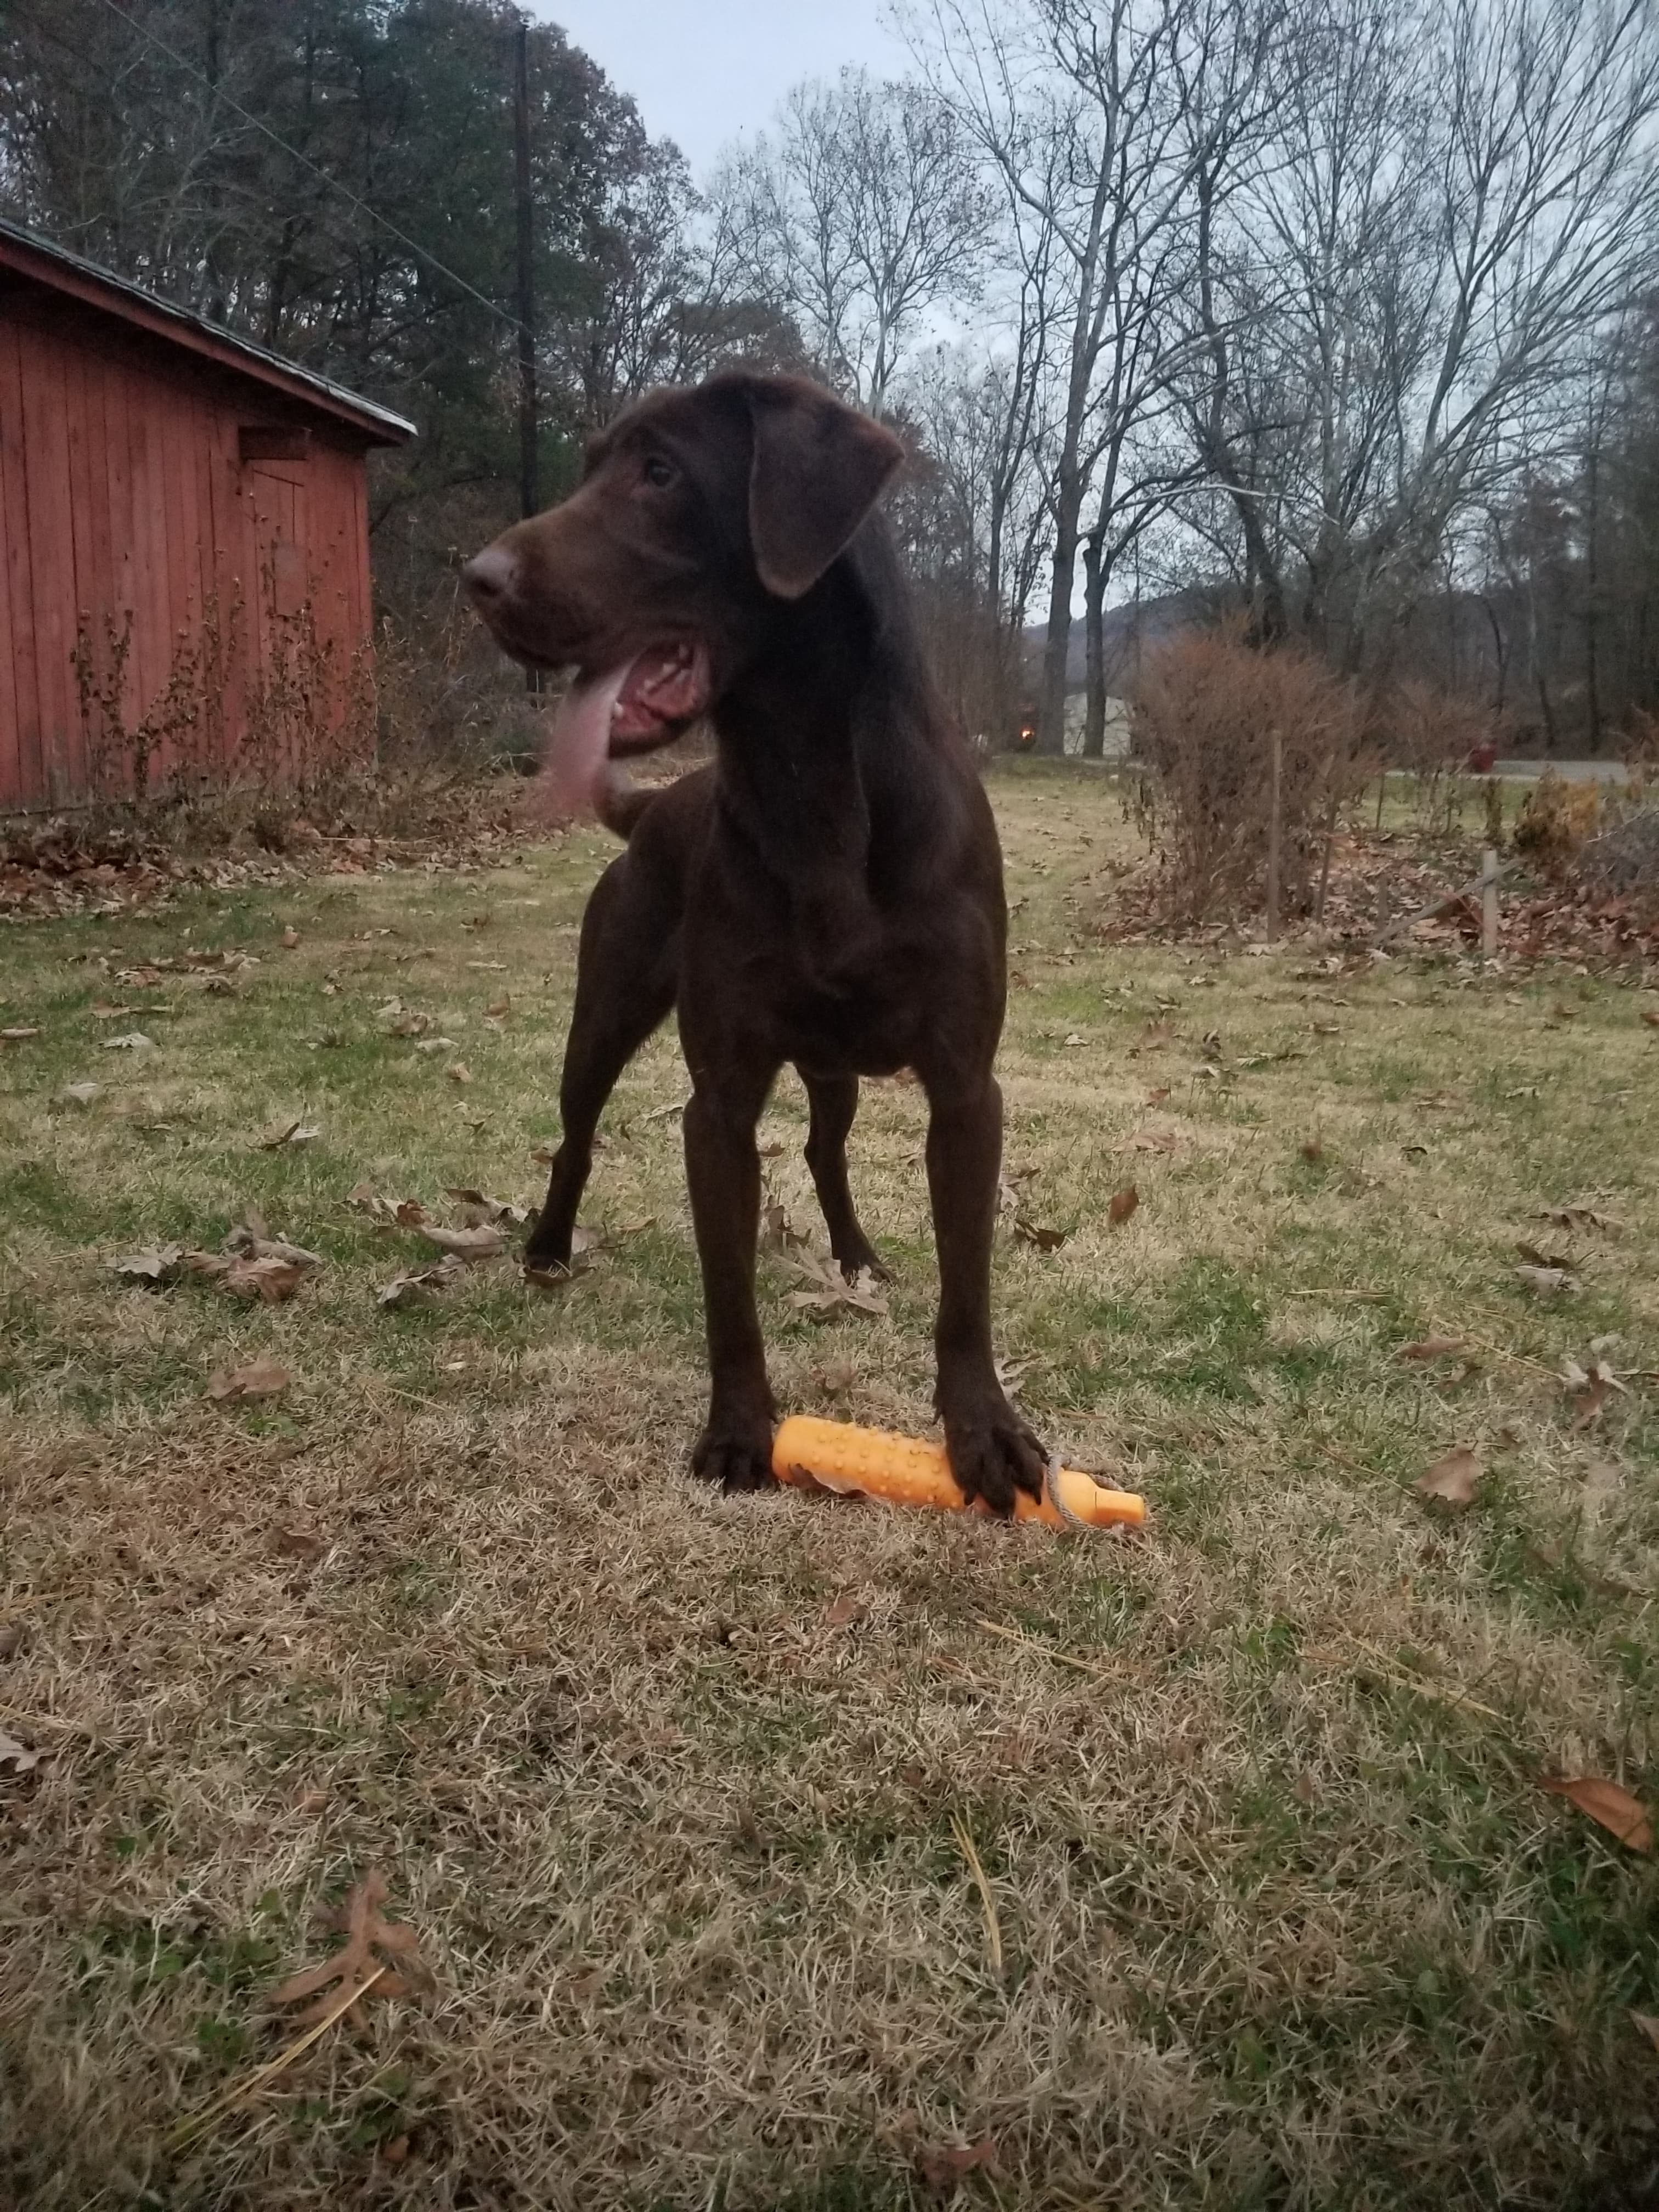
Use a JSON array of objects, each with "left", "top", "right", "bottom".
[{"left": 531, "top": 0, "right": 909, "bottom": 177}]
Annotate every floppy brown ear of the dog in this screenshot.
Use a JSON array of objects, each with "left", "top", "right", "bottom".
[{"left": 750, "top": 376, "right": 905, "bottom": 600}]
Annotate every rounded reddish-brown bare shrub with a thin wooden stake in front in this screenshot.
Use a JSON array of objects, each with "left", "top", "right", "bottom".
[{"left": 1130, "top": 630, "right": 1369, "bottom": 922}]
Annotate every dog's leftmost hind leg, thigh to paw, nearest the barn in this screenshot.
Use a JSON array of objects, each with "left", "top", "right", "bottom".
[{"left": 524, "top": 854, "right": 679, "bottom": 1272}]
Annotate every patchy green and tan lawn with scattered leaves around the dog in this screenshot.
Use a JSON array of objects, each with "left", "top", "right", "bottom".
[{"left": 0, "top": 772, "right": 1659, "bottom": 2212}]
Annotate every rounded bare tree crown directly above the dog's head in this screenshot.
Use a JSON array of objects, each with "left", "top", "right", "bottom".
[{"left": 712, "top": 69, "right": 993, "bottom": 414}]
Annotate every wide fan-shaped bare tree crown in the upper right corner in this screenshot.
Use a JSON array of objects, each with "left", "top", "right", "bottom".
[{"left": 1190, "top": 0, "right": 1659, "bottom": 668}]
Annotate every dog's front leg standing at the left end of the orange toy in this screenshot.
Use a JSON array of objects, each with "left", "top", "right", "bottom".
[{"left": 686, "top": 1068, "right": 776, "bottom": 1491}]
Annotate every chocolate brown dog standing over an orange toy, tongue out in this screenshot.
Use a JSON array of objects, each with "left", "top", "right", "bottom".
[{"left": 465, "top": 371, "right": 1046, "bottom": 1513}]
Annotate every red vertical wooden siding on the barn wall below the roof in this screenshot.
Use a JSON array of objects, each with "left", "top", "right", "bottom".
[{"left": 0, "top": 267, "right": 400, "bottom": 808}]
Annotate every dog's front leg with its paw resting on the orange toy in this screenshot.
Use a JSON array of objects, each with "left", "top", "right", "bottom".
[{"left": 922, "top": 1075, "right": 1046, "bottom": 1513}]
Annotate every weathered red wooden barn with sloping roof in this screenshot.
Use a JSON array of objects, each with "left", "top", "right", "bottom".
[{"left": 0, "top": 221, "right": 414, "bottom": 808}]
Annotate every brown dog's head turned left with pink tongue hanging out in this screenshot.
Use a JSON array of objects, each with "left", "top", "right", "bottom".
[{"left": 462, "top": 369, "right": 902, "bottom": 814}]
